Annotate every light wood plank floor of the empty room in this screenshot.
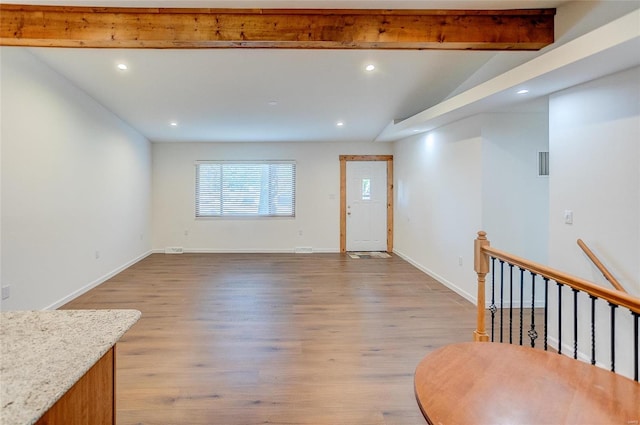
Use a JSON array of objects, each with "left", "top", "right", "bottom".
[{"left": 63, "top": 254, "right": 475, "bottom": 425}]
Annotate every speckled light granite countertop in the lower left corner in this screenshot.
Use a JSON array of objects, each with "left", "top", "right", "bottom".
[{"left": 0, "top": 310, "right": 141, "bottom": 425}]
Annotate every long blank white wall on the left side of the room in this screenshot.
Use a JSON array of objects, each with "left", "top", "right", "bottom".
[{"left": 0, "top": 47, "right": 151, "bottom": 310}]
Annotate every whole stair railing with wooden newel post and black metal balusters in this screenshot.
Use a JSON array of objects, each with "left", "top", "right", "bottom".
[{"left": 474, "top": 231, "right": 640, "bottom": 381}]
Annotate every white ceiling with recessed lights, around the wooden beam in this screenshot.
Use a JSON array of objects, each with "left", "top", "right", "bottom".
[{"left": 11, "top": 0, "right": 636, "bottom": 142}]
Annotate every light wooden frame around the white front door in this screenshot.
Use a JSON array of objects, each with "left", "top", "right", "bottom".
[{"left": 340, "top": 155, "right": 393, "bottom": 252}]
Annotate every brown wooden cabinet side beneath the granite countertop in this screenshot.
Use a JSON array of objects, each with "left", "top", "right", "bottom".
[{"left": 36, "top": 346, "right": 116, "bottom": 425}]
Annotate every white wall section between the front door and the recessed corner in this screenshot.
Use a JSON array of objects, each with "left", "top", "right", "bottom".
[{"left": 394, "top": 117, "right": 482, "bottom": 300}]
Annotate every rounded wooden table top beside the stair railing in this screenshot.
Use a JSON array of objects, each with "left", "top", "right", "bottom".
[{"left": 415, "top": 342, "right": 640, "bottom": 425}]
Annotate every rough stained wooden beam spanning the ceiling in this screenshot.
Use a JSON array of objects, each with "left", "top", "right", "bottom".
[{"left": 0, "top": 4, "right": 555, "bottom": 50}]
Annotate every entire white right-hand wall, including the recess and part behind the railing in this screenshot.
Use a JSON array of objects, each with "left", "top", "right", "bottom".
[{"left": 394, "top": 68, "right": 640, "bottom": 376}]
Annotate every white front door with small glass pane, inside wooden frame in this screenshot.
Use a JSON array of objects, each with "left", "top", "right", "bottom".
[{"left": 346, "top": 161, "right": 387, "bottom": 251}]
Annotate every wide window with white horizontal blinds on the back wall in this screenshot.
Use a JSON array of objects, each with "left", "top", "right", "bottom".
[{"left": 196, "top": 161, "right": 296, "bottom": 217}]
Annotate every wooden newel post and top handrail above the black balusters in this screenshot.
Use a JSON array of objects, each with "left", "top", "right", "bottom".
[{"left": 475, "top": 231, "right": 640, "bottom": 314}]
